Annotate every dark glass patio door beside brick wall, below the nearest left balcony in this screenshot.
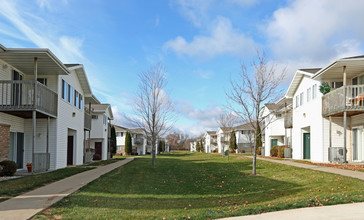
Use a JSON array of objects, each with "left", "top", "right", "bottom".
[{"left": 9, "top": 132, "right": 24, "bottom": 169}]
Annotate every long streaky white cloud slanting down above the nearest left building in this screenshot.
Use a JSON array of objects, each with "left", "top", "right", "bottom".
[{"left": 0, "top": 1, "right": 85, "bottom": 63}]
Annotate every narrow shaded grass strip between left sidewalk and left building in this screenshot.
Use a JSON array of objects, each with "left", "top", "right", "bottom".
[{"left": 0, "top": 167, "right": 93, "bottom": 202}]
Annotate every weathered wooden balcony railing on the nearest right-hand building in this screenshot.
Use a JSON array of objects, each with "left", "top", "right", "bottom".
[{"left": 322, "top": 85, "right": 364, "bottom": 116}]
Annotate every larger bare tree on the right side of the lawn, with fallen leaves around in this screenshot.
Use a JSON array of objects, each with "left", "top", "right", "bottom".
[{"left": 226, "top": 51, "right": 286, "bottom": 175}]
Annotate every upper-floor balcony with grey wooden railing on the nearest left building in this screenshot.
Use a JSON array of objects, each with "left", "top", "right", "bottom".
[{"left": 0, "top": 80, "right": 58, "bottom": 118}]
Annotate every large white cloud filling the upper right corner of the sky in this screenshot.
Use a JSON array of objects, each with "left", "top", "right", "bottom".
[{"left": 264, "top": 0, "right": 364, "bottom": 63}]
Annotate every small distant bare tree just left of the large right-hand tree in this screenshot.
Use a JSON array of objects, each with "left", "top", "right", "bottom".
[{"left": 216, "top": 112, "right": 238, "bottom": 160}]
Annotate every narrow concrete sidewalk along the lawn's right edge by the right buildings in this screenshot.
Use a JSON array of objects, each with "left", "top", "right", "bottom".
[{"left": 249, "top": 157, "right": 364, "bottom": 180}]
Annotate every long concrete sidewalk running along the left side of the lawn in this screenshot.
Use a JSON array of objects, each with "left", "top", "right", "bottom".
[{"left": 0, "top": 158, "right": 134, "bottom": 219}]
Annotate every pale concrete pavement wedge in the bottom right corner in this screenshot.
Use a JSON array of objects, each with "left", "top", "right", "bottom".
[{"left": 225, "top": 203, "right": 364, "bottom": 220}]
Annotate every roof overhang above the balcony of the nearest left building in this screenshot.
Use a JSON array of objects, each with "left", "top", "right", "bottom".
[{"left": 0, "top": 45, "right": 70, "bottom": 75}]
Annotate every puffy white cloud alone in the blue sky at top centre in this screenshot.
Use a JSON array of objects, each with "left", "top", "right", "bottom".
[{"left": 163, "top": 16, "right": 257, "bottom": 59}]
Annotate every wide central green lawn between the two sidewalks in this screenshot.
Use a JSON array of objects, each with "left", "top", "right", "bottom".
[{"left": 35, "top": 153, "right": 364, "bottom": 219}]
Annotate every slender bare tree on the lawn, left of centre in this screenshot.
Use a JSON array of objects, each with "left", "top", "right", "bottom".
[{"left": 134, "top": 63, "right": 175, "bottom": 166}]
